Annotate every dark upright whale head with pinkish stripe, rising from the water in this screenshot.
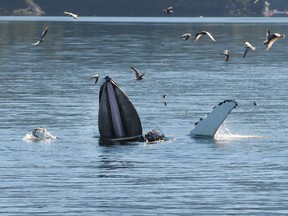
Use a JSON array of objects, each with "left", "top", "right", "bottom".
[{"left": 98, "top": 76, "right": 144, "bottom": 142}]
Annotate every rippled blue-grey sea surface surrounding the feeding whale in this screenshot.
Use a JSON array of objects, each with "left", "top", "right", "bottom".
[{"left": 0, "top": 16, "right": 288, "bottom": 216}]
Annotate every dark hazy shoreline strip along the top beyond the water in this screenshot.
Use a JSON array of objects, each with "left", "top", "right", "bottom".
[{"left": 0, "top": 0, "right": 288, "bottom": 17}]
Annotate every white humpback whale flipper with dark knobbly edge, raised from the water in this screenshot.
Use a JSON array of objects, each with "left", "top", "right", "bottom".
[{"left": 190, "top": 100, "right": 238, "bottom": 137}]
